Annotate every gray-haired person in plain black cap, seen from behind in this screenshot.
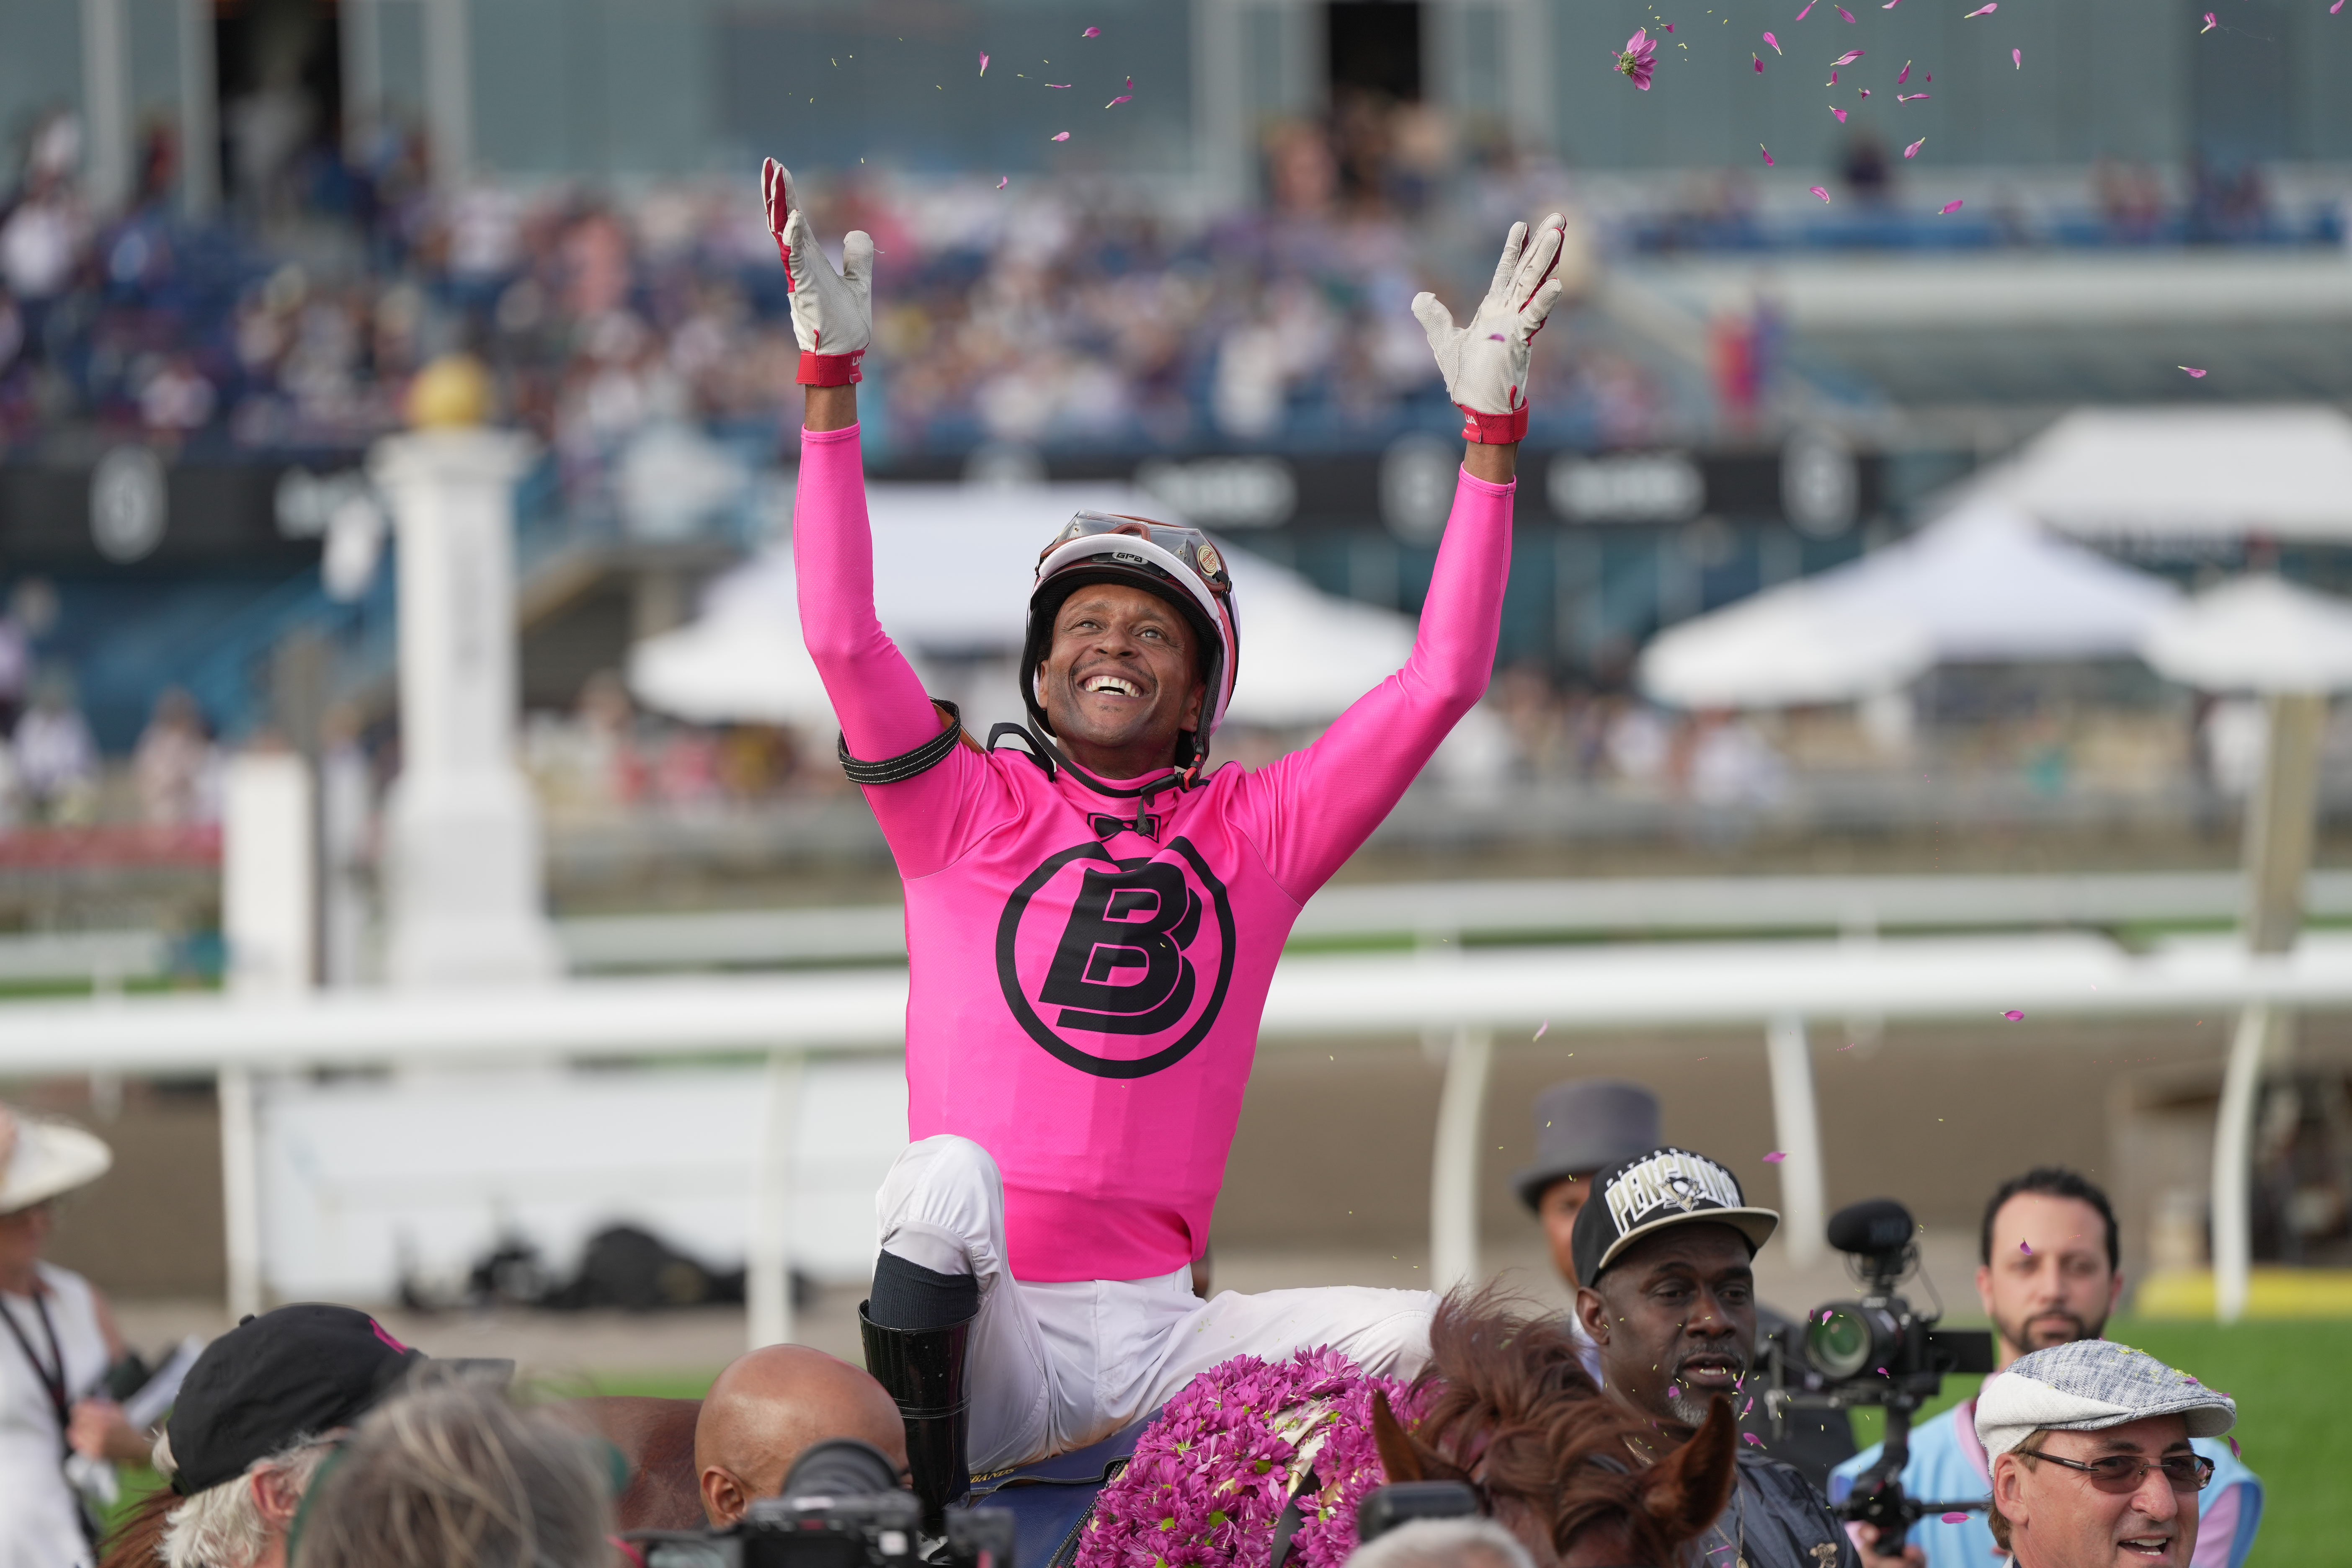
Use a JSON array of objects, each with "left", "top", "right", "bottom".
[{"left": 153, "top": 1302, "right": 513, "bottom": 1568}]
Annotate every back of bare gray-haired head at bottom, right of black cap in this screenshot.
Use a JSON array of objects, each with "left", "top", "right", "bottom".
[{"left": 294, "top": 1375, "right": 621, "bottom": 1568}]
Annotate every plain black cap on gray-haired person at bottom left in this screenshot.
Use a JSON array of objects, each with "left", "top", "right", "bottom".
[{"left": 165, "top": 1302, "right": 426, "bottom": 1498}]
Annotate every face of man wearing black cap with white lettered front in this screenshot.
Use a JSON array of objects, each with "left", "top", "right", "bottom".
[{"left": 1576, "top": 1222, "right": 1757, "bottom": 1427}]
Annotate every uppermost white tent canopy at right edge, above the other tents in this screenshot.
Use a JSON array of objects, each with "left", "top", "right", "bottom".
[{"left": 1992, "top": 404, "right": 2352, "bottom": 541}]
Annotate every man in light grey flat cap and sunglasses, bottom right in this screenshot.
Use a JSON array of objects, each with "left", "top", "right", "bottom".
[{"left": 1975, "top": 1340, "right": 2237, "bottom": 1568}]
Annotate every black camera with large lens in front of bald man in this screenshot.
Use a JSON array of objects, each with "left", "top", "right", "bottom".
[{"left": 623, "top": 1436, "right": 1014, "bottom": 1568}]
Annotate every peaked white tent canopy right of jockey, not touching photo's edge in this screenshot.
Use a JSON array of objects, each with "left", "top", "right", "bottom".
[{"left": 1639, "top": 494, "right": 2178, "bottom": 708}]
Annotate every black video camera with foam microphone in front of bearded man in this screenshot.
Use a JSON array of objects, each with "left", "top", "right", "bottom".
[{"left": 1764, "top": 1199, "right": 1992, "bottom": 1542}]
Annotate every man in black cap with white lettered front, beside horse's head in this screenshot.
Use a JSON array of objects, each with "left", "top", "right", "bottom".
[{"left": 1569, "top": 1147, "right": 1858, "bottom": 1568}]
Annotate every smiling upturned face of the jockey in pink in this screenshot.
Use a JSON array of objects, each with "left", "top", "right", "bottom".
[{"left": 1037, "top": 583, "right": 1207, "bottom": 778}]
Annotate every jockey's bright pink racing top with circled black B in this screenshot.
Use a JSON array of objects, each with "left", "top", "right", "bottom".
[{"left": 793, "top": 426, "right": 1512, "bottom": 1281}]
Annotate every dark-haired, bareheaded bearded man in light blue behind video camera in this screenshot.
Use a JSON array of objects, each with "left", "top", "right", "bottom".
[{"left": 1830, "top": 1166, "right": 2263, "bottom": 1568}]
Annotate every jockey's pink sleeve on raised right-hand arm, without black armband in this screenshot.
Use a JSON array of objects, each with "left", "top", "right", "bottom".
[{"left": 1242, "top": 470, "right": 1517, "bottom": 903}]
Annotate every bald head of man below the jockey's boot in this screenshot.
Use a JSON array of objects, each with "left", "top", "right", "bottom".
[{"left": 694, "top": 1345, "right": 905, "bottom": 1526}]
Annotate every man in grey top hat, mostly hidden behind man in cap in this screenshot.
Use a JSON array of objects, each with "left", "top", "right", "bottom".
[{"left": 1512, "top": 1079, "right": 1853, "bottom": 1488}]
